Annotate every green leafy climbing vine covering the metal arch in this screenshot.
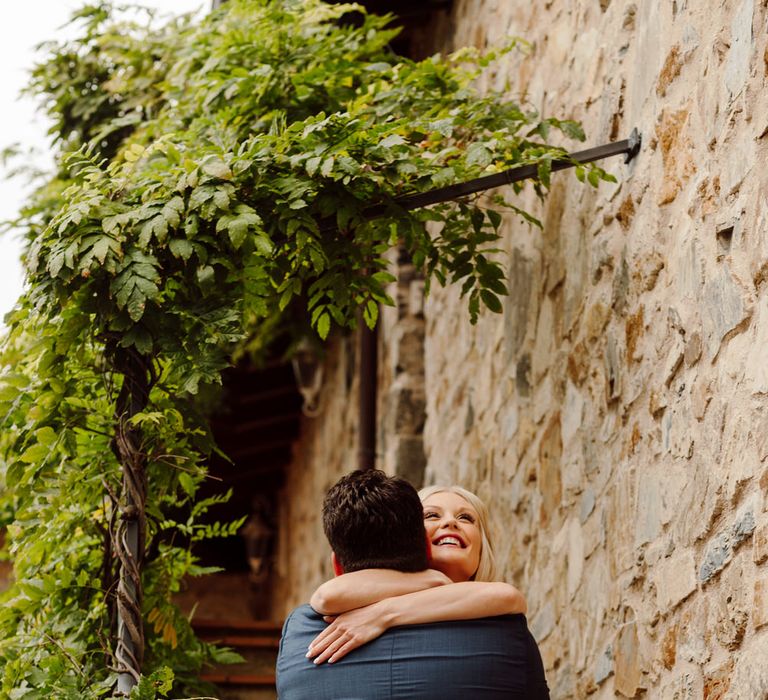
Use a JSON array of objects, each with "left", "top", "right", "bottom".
[{"left": 0, "top": 0, "right": 611, "bottom": 698}]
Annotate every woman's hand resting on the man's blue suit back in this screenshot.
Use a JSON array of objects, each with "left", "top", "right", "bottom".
[{"left": 307, "top": 603, "right": 389, "bottom": 664}]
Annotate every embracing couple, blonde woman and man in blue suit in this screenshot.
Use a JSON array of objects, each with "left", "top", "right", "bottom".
[{"left": 277, "top": 470, "right": 549, "bottom": 700}]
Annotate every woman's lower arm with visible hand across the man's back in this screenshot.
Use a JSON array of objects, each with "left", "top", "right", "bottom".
[{"left": 307, "top": 581, "right": 527, "bottom": 664}]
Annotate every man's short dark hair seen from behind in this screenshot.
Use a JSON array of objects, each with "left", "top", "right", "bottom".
[{"left": 323, "top": 469, "right": 428, "bottom": 572}]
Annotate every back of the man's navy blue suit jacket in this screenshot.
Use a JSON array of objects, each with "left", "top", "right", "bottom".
[{"left": 277, "top": 605, "right": 549, "bottom": 700}]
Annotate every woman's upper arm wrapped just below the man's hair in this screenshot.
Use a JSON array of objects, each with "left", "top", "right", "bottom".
[{"left": 309, "top": 569, "right": 451, "bottom": 615}]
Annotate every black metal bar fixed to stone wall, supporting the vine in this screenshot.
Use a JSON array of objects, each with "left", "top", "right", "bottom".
[{"left": 384, "top": 129, "right": 643, "bottom": 212}]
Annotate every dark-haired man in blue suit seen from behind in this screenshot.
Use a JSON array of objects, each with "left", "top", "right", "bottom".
[{"left": 277, "top": 470, "right": 549, "bottom": 700}]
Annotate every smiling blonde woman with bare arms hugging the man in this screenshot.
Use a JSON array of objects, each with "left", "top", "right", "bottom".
[{"left": 307, "top": 486, "right": 526, "bottom": 664}]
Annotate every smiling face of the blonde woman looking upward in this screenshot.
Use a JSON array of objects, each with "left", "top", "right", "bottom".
[{"left": 423, "top": 491, "right": 482, "bottom": 582}]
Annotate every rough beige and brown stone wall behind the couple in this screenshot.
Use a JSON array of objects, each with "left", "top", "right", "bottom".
[{"left": 270, "top": 0, "right": 768, "bottom": 700}]
